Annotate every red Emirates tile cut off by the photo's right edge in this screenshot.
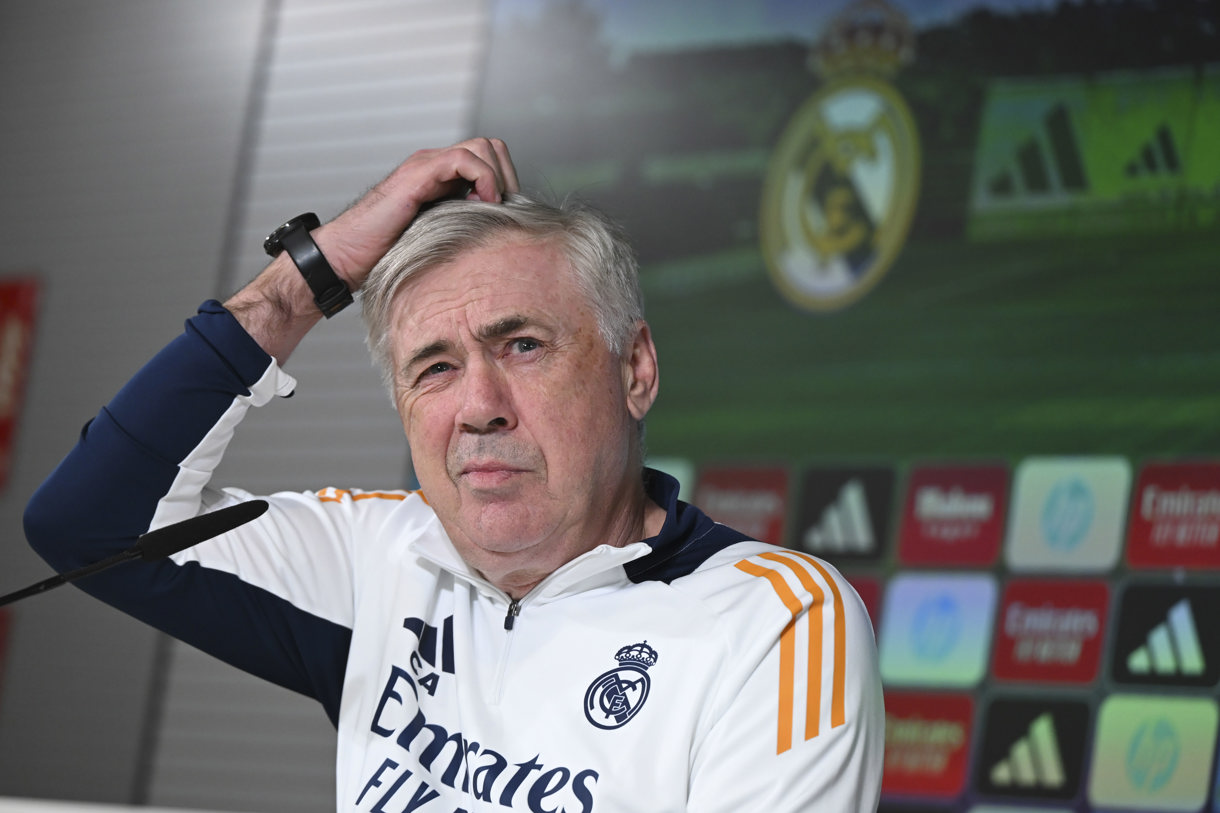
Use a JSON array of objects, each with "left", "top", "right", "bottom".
[{"left": 1127, "top": 461, "right": 1220, "bottom": 568}]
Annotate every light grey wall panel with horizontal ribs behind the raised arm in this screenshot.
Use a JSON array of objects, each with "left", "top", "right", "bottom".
[{"left": 142, "top": 0, "right": 487, "bottom": 813}]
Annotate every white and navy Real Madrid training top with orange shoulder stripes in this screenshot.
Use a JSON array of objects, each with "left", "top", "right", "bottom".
[{"left": 29, "top": 303, "right": 883, "bottom": 813}]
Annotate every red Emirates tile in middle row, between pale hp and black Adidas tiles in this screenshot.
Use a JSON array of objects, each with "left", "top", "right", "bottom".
[{"left": 992, "top": 579, "right": 1110, "bottom": 684}]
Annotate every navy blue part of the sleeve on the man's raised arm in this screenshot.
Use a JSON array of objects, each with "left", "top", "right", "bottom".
[{"left": 24, "top": 302, "right": 350, "bottom": 721}]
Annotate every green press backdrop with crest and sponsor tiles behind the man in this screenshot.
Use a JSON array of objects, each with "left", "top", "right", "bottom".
[{"left": 476, "top": 0, "right": 1220, "bottom": 811}]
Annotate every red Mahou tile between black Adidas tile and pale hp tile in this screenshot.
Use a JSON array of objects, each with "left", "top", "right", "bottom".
[{"left": 898, "top": 465, "right": 1008, "bottom": 566}]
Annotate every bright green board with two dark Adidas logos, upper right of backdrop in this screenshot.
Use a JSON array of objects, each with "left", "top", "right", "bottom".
[{"left": 967, "top": 68, "right": 1216, "bottom": 239}]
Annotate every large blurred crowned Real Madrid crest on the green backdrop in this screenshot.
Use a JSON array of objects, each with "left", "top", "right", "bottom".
[{"left": 760, "top": 0, "right": 920, "bottom": 311}]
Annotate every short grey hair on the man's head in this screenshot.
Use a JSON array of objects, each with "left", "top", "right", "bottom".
[{"left": 361, "top": 194, "right": 644, "bottom": 393}]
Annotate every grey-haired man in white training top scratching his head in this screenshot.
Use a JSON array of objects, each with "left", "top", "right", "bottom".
[{"left": 27, "top": 139, "right": 883, "bottom": 813}]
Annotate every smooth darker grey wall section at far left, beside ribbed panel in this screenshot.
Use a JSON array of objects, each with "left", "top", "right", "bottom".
[{"left": 0, "top": 0, "right": 262, "bottom": 802}]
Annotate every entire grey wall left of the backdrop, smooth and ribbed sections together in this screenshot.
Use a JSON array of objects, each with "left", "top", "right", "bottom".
[{"left": 0, "top": 0, "right": 487, "bottom": 811}]
